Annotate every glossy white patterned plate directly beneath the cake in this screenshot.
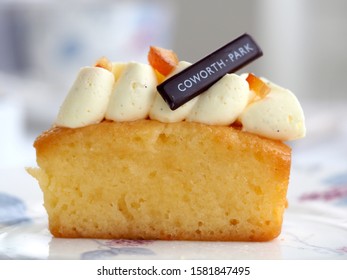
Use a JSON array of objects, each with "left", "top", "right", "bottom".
[{"left": 0, "top": 211, "right": 347, "bottom": 259}]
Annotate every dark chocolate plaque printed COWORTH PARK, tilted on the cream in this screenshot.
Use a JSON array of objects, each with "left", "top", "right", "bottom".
[{"left": 157, "top": 34, "right": 263, "bottom": 110}]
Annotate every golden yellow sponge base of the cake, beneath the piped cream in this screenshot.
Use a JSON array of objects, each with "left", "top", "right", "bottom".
[{"left": 28, "top": 120, "right": 291, "bottom": 241}]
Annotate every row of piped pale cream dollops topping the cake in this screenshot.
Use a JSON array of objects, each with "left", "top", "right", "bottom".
[{"left": 55, "top": 61, "right": 306, "bottom": 141}]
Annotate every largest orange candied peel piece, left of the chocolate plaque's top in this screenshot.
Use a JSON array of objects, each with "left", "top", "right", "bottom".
[{"left": 148, "top": 46, "right": 178, "bottom": 76}]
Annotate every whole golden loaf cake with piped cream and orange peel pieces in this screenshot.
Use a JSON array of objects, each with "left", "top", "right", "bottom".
[{"left": 28, "top": 36, "right": 305, "bottom": 241}]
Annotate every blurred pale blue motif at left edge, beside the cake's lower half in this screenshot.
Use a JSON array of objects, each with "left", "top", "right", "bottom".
[{"left": 0, "top": 192, "right": 29, "bottom": 225}]
